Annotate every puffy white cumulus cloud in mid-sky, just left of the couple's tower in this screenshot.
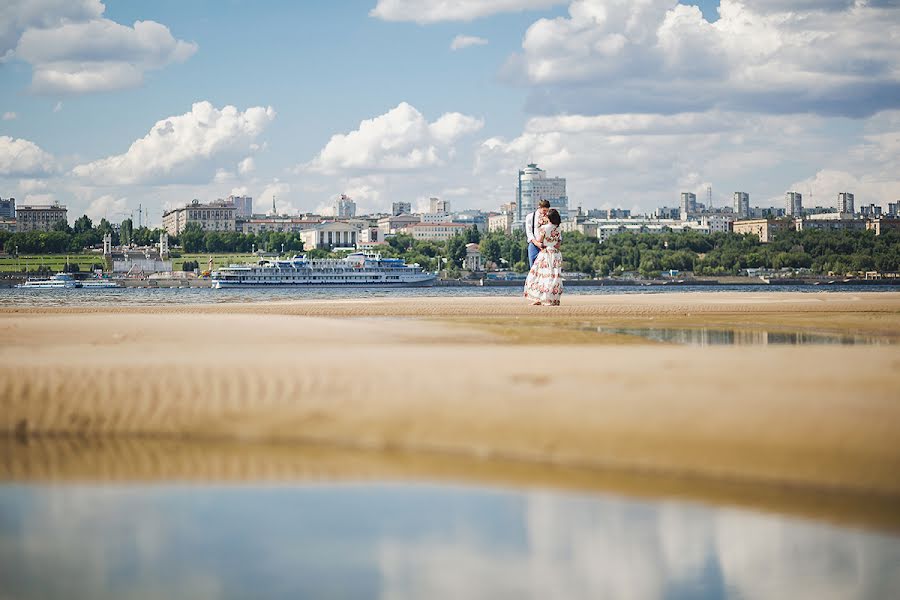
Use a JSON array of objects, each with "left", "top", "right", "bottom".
[{"left": 301, "top": 102, "right": 484, "bottom": 173}]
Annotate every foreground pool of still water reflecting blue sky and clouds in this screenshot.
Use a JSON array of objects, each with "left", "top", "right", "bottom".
[{"left": 0, "top": 485, "right": 900, "bottom": 600}]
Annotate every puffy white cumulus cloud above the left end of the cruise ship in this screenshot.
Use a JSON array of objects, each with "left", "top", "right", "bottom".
[{"left": 72, "top": 101, "right": 275, "bottom": 185}]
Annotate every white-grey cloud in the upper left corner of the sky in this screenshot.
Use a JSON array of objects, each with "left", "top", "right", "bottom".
[{"left": 3, "top": 1, "right": 197, "bottom": 94}]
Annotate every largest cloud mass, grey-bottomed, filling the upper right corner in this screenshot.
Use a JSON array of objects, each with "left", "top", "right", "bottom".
[{"left": 505, "top": 0, "right": 900, "bottom": 117}]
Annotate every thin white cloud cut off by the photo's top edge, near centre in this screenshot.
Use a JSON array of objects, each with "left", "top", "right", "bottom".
[{"left": 369, "top": 0, "right": 565, "bottom": 24}]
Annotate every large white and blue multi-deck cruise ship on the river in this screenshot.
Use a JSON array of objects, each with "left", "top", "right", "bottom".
[{"left": 210, "top": 252, "right": 437, "bottom": 289}]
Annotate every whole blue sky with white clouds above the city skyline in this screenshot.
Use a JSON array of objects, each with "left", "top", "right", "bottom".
[{"left": 0, "top": 0, "right": 900, "bottom": 224}]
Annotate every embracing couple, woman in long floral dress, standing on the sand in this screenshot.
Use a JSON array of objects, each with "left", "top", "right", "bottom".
[{"left": 525, "top": 200, "right": 562, "bottom": 306}]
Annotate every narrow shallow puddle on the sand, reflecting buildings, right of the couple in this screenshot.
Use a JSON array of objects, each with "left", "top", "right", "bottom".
[{"left": 597, "top": 327, "right": 900, "bottom": 346}]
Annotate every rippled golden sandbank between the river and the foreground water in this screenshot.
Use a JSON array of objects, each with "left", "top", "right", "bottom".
[{"left": 0, "top": 292, "right": 900, "bottom": 528}]
